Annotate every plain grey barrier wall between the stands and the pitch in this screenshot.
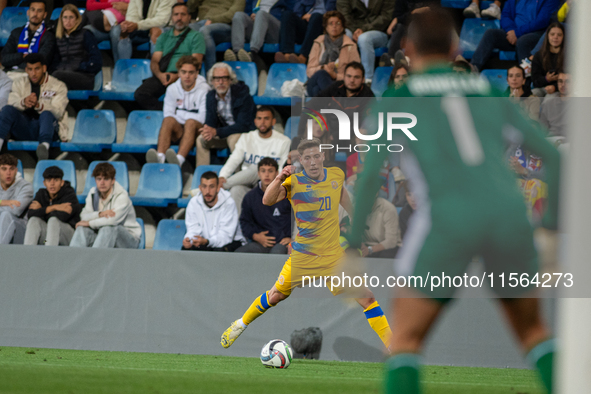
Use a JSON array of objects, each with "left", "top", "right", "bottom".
[{"left": 0, "top": 245, "right": 554, "bottom": 368}]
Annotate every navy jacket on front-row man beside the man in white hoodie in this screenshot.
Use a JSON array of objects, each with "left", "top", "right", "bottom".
[{"left": 240, "top": 182, "right": 291, "bottom": 243}]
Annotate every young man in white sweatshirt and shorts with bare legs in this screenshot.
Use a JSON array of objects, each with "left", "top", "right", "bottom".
[{"left": 146, "top": 56, "right": 210, "bottom": 166}]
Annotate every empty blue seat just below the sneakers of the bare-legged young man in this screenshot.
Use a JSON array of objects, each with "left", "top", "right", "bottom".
[{"left": 131, "top": 163, "right": 183, "bottom": 207}]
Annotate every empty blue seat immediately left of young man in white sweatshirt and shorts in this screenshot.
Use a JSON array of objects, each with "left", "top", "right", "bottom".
[{"left": 111, "top": 111, "right": 162, "bottom": 153}]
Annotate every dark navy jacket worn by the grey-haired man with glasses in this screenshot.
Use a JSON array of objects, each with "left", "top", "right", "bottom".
[{"left": 205, "top": 81, "right": 256, "bottom": 138}]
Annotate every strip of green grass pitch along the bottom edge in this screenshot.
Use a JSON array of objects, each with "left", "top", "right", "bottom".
[{"left": 0, "top": 347, "right": 543, "bottom": 394}]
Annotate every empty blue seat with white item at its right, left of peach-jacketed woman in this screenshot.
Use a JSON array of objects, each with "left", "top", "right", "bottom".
[{"left": 254, "top": 63, "right": 308, "bottom": 106}]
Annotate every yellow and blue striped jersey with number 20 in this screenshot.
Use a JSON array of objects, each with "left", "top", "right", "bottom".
[{"left": 283, "top": 167, "right": 345, "bottom": 257}]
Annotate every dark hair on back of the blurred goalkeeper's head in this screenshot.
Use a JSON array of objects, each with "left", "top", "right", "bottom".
[{"left": 407, "top": 6, "right": 454, "bottom": 56}]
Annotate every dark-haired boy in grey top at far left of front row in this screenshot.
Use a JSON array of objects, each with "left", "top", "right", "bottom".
[{"left": 0, "top": 153, "right": 33, "bottom": 245}]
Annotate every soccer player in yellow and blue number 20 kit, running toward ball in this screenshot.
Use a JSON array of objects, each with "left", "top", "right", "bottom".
[{"left": 221, "top": 139, "right": 391, "bottom": 348}]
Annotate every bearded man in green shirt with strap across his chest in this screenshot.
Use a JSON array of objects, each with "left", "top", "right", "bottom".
[{"left": 134, "top": 3, "right": 205, "bottom": 111}]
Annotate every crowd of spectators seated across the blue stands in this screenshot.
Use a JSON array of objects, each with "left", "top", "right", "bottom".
[{"left": 0, "top": 0, "right": 575, "bottom": 252}]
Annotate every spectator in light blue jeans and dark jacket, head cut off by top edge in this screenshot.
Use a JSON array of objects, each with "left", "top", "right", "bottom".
[{"left": 337, "top": 0, "right": 394, "bottom": 84}]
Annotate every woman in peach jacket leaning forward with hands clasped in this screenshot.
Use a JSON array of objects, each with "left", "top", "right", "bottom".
[{"left": 306, "top": 11, "right": 361, "bottom": 97}]
